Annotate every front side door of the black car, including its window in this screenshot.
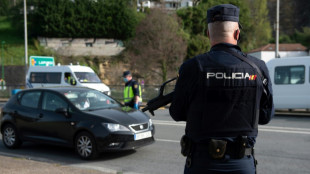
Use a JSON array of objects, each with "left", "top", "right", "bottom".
[{"left": 37, "top": 91, "right": 75, "bottom": 144}]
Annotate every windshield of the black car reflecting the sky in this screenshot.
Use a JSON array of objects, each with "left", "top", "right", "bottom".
[{"left": 63, "top": 90, "right": 120, "bottom": 111}]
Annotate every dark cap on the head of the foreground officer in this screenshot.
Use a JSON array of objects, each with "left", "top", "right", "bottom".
[{"left": 207, "top": 4, "right": 239, "bottom": 23}]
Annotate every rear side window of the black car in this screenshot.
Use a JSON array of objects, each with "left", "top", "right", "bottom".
[{"left": 20, "top": 91, "right": 41, "bottom": 108}]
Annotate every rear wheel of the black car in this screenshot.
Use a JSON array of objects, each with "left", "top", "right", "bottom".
[{"left": 2, "top": 124, "right": 22, "bottom": 149}]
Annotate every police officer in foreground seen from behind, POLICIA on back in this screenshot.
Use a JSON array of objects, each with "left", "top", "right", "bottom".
[{"left": 170, "top": 4, "right": 274, "bottom": 174}]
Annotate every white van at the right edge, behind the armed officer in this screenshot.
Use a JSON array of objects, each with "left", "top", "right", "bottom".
[{"left": 266, "top": 56, "right": 310, "bottom": 109}]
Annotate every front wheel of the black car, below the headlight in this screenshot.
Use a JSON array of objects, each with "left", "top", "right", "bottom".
[{"left": 75, "top": 132, "right": 98, "bottom": 160}]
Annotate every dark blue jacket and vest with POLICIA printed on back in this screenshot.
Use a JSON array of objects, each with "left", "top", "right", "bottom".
[{"left": 170, "top": 43, "right": 274, "bottom": 146}]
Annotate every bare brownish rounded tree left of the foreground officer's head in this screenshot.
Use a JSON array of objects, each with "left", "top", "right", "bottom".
[{"left": 125, "top": 9, "right": 186, "bottom": 82}]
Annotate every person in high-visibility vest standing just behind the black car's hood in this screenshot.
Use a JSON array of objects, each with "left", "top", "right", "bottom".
[{"left": 123, "top": 71, "right": 142, "bottom": 109}]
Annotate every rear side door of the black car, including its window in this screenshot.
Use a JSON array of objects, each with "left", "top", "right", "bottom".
[{"left": 14, "top": 90, "right": 42, "bottom": 139}]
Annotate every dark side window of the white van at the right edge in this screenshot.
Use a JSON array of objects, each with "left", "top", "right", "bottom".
[{"left": 274, "top": 65, "right": 305, "bottom": 85}]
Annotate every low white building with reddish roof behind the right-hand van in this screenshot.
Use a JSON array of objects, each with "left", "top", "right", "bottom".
[{"left": 248, "top": 43, "right": 309, "bottom": 62}]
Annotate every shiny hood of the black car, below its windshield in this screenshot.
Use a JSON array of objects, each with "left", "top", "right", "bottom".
[{"left": 87, "top": 107, "right": 150, "bottom": 125}]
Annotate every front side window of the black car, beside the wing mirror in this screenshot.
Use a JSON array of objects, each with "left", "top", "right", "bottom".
[{"left": 42, "top": 92, "right": 68, "bottom": 111}]
